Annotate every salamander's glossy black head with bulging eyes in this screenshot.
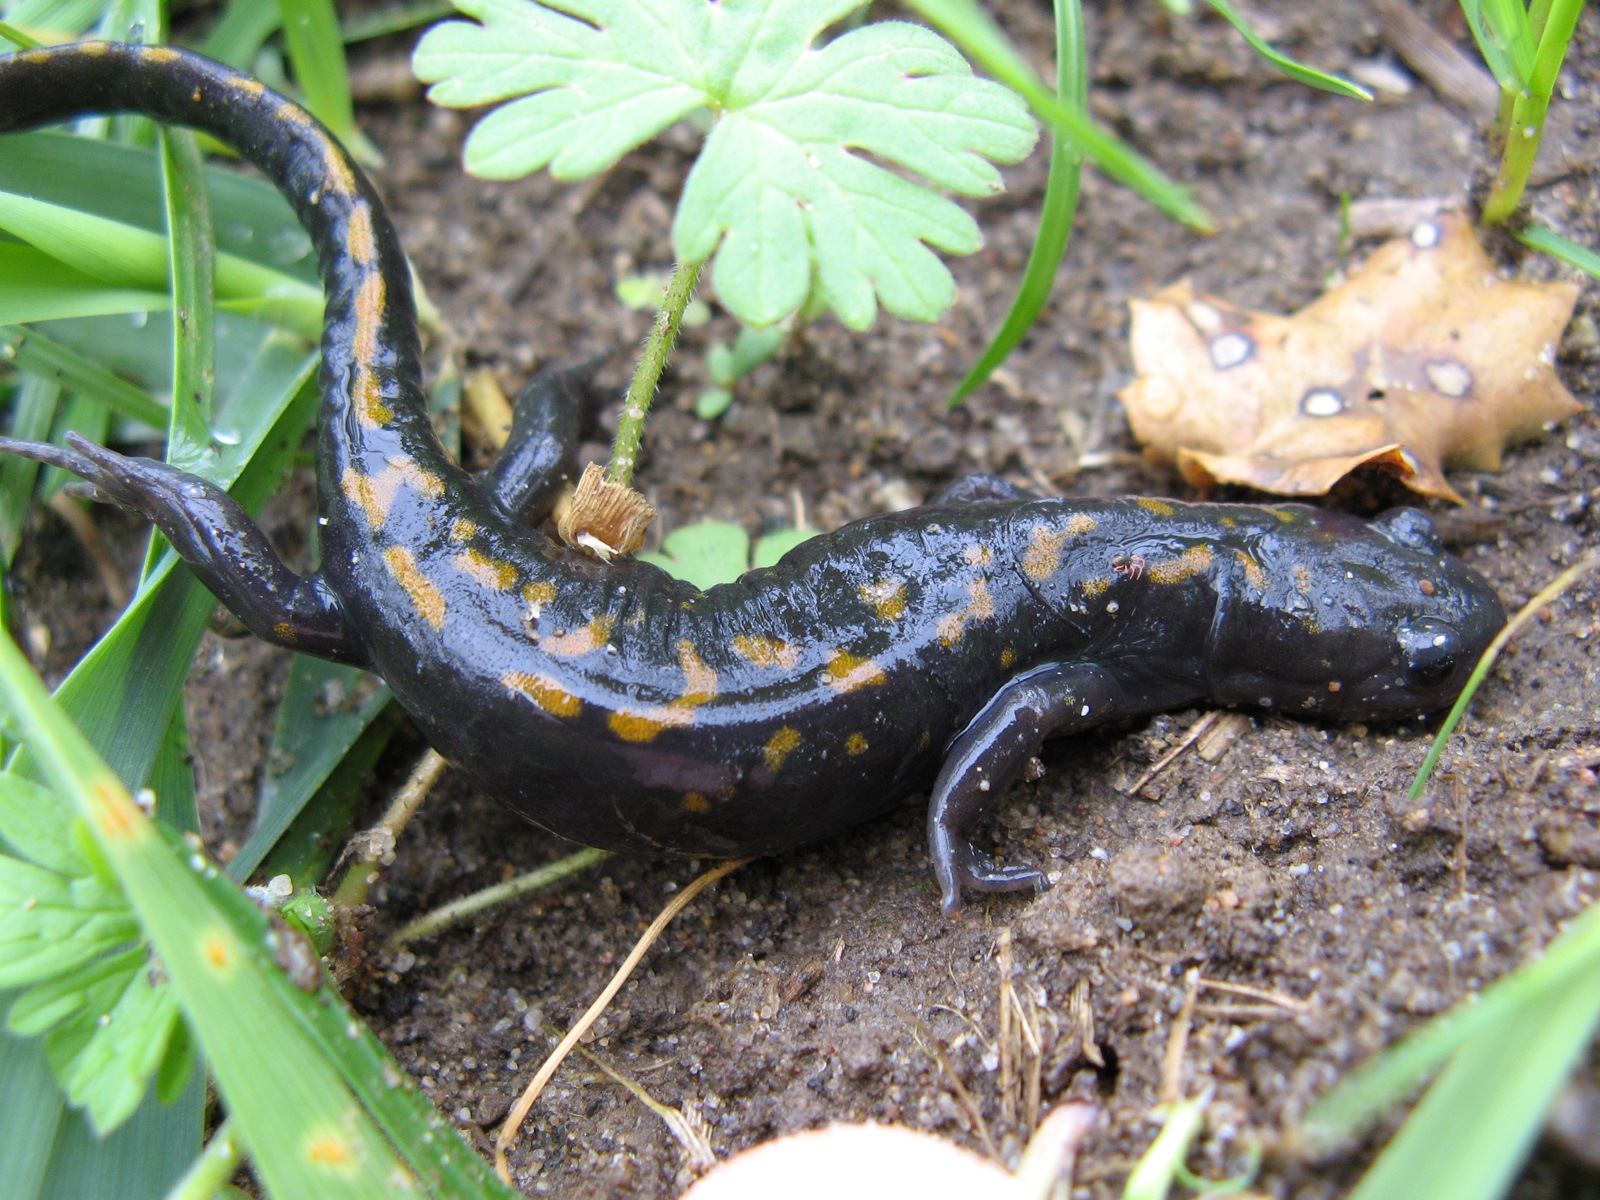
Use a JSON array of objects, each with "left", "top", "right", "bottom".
[{"left": 1206, "top": 507, "right": 1506, "bottom": 720}]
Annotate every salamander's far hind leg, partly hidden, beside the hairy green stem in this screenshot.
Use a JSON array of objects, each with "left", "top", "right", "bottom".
[{"left": 482, "top": 362, "right": 597, "bottom": 522}]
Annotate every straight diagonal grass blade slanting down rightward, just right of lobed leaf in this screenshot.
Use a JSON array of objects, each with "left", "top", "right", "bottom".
[{"left": 910, "top": 0, "right": 1216, "bottom": 234}]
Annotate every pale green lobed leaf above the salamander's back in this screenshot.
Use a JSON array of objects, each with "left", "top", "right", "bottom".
[{"left": 414, "top": 0, "right": 1037, "bottom": 330}]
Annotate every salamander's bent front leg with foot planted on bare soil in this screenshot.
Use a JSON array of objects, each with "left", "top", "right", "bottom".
[{"left": 928, "top": 664, "right": 1120, "bottom": 914}]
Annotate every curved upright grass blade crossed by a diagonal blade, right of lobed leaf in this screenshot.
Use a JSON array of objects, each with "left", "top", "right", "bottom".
[{"left": 949, "top": 0, "right": 1088, "bottom": 408}]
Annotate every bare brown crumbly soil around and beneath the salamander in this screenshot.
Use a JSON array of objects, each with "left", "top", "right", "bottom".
[{"left": 12, "top": 0, "right": 1600, "bottom": 1198}]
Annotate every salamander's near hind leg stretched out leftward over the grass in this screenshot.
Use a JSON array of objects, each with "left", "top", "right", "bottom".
[{"left": 0, "top": 434, "right": 366, "bottom": 666}]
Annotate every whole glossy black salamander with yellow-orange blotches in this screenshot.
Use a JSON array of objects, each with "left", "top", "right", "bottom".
[{"left": 0, "top": 42, "right": 1504, "bottom": 912}]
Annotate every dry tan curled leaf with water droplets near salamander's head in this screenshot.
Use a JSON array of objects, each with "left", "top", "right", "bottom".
[{"left": 1122, "top": 213, "right": 1581, "bottom": 502}]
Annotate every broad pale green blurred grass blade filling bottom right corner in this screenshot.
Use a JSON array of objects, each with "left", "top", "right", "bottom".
[{"left": 1350, "top": 963, "right": 1600, "bottom": 1200}]
